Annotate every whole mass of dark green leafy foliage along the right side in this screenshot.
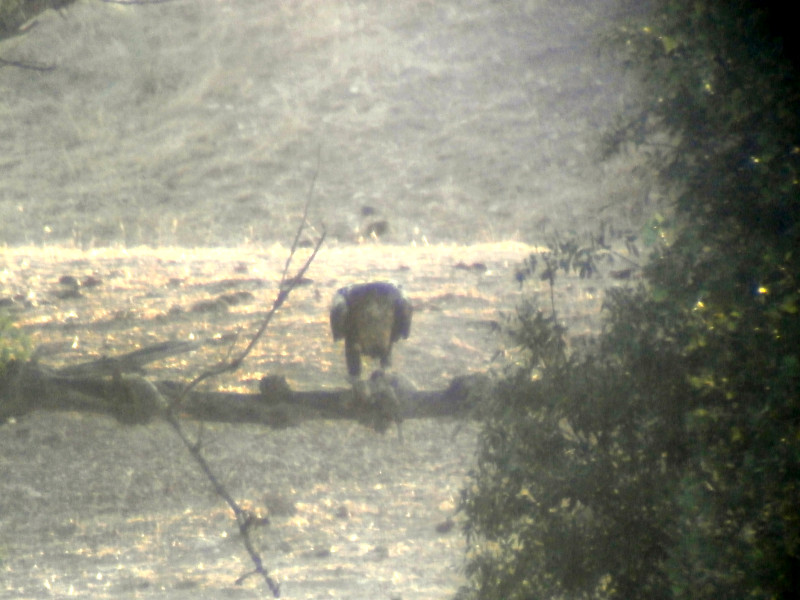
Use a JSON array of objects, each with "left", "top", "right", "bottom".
[{"left": 462, "top": 0, "right": 800, "bottom": 599}]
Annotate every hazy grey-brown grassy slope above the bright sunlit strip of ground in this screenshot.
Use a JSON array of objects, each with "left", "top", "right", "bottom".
[{"left": 0, "top": 0, "right": 644, "bottom": 248}]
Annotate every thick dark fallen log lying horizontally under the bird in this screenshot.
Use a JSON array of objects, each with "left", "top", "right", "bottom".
[{"left": 0, "top": 361, "right": 493, "bottom": 431}]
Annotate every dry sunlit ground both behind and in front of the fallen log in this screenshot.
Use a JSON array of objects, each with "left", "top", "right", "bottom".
[{"left": 0, "top": 243, "right": 632, "bottom": 599}]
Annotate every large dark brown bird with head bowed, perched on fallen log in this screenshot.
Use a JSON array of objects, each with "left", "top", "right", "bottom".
[{"left": 331, "top": 281, "right": 413, "bottom": 380}]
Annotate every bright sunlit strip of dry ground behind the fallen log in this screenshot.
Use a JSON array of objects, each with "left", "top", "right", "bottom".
[{"left": 0, "top": 243, "right": 608, "bottom": 391}]
